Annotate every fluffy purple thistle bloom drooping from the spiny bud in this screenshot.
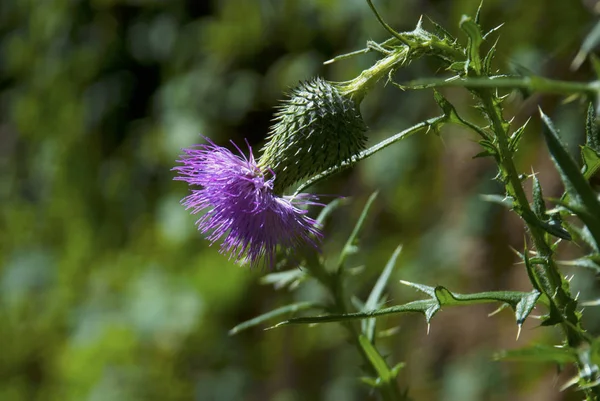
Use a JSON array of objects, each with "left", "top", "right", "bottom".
[{"left": 173, "top": 138, "right": 322, "bottom": 267}]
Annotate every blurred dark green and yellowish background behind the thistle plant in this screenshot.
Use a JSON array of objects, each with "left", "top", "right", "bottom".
[{"left": 0, "top": 0, "right": 600, "bottom": 401}]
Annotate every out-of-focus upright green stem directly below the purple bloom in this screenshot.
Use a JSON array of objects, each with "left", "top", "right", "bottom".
[{"left": 307, "top": 252, "right": 404, "bottom": 401}]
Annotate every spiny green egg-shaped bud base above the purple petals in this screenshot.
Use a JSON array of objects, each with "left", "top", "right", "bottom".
[{"left": 258, "top": 78, "right": 367, "bottom": 193}]
